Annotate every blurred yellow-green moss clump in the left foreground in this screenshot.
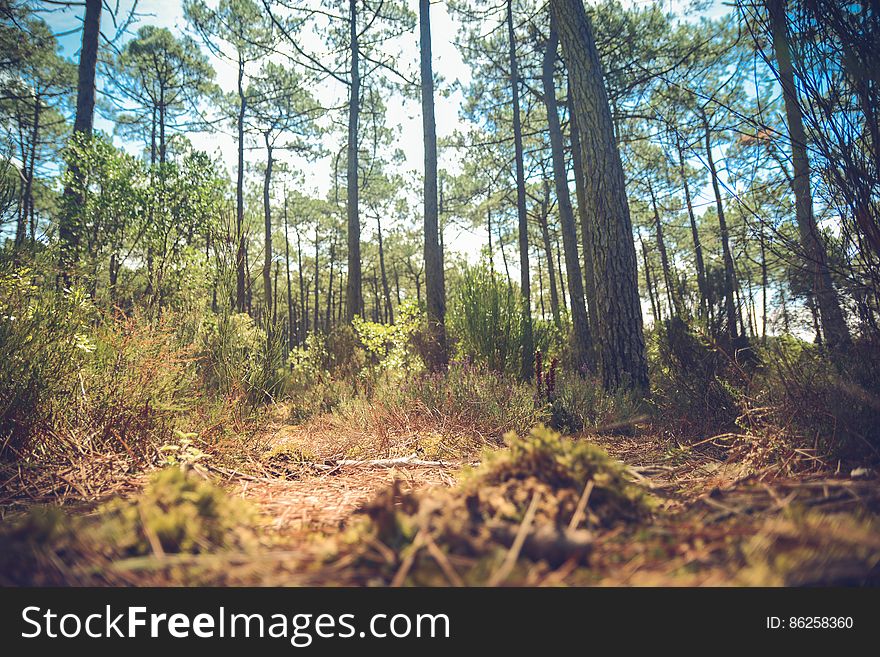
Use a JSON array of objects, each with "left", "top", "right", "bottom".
[{"left": 97, "top": 468, "right": 256, "bottom": 556}]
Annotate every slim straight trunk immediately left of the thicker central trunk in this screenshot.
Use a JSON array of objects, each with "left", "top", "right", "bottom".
[{"left": 346, "top": 0, "right": 364, "bottom": 322}]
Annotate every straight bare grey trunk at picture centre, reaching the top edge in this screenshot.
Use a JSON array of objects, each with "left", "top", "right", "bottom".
[{"left": 420, "top": 0, "right": 448, "bottom": 369}]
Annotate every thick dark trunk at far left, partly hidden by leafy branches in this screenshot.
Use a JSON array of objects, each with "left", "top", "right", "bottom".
[{"left": 58, "top": 0, "right": 104, "bottom": 280}]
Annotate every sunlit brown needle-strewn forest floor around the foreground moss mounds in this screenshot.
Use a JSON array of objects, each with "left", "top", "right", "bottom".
[{"left": 0, "top": 404, "right": 880, "bottom": 586}]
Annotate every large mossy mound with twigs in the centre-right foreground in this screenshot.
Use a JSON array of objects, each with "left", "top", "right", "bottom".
[{"left": 341, "top": 426, "right": 652, "bottom": 585}]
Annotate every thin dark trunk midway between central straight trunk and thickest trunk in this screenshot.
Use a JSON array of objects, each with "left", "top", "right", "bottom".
[{"left": 507, "top": 0, "right": 535, "bottom": 381}]
